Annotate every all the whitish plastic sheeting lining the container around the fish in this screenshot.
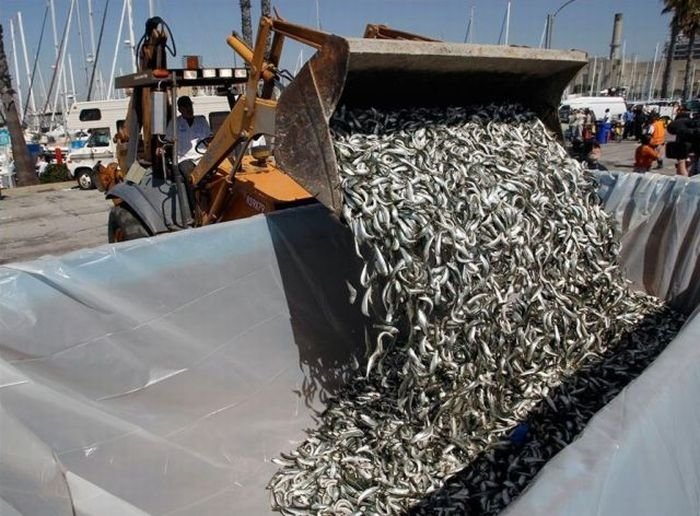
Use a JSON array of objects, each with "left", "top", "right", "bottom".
[{"left": 0, "top": 174, "right": 700, "bottom": 516}]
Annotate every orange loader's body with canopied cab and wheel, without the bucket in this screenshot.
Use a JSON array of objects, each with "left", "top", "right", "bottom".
[{"left": 106, "top": 62, "right": 316, "bottom": 242}]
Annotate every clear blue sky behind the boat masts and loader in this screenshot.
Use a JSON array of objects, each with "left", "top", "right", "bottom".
[{"left": 0, "top": 0, "right": 670, "bottom": 107}]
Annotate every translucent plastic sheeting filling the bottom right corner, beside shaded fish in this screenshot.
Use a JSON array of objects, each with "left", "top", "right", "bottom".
[{"left": 504, "top": 308, "right": 700, "bottom": 516}]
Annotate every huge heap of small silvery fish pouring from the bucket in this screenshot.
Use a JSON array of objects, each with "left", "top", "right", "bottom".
[{"left": 269, "top": 105, "right": 682, "bottom": 515}]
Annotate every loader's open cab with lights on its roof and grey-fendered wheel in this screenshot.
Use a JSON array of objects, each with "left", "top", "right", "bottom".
[{"left": 105, "top": 68, "right": 253, "bottom": 242}]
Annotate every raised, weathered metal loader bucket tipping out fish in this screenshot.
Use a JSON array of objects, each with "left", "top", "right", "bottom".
[{"left": 275, "top": 35, "right": 586, "bottom": 213}]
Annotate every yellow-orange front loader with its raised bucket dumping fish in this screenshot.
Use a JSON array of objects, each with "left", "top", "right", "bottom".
[{"left": 102, "top": 17, "right": 586, "bottom": 241}]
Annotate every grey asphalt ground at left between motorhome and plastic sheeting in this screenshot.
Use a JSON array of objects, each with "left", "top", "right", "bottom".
[{"left": 0, "top": 181, "right": 112, "bottom": 263}]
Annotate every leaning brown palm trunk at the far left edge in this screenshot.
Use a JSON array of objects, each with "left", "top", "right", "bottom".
[{"left": 0, "top": 25, "right": 39, "bottom": 186}]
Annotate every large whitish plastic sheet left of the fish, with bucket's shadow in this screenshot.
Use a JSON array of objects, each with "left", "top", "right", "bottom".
[{"left": 0, "top": 206, "right": 362, "bottom": 516}]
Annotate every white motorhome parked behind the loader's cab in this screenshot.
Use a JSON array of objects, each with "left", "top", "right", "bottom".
[{"left": 66, "top": 95, "right": 231, "bottom": 190}]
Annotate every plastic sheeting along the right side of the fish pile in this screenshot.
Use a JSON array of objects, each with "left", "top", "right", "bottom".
[{"left": 505, "top": 172, "right": 700, "bottom": 516}]
